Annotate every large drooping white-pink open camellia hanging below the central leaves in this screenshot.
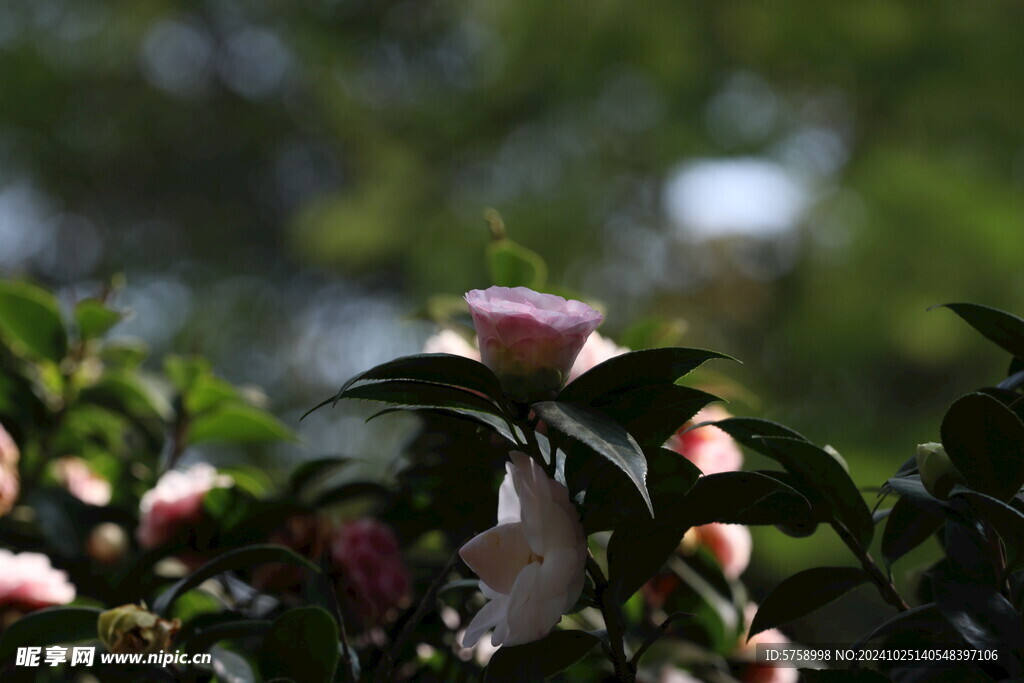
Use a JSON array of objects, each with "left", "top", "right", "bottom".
[{"left": 459, "top": 451, "right": 587, "bottom": 647}]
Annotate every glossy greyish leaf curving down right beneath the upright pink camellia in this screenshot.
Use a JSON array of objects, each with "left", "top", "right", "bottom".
[{"left": 532, "top": 400, "right": 654, "bottom": 516}]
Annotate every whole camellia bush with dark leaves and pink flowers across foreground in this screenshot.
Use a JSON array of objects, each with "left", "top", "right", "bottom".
[{"left": 0, "top": 232, "right": 1024, "bottom": 682}]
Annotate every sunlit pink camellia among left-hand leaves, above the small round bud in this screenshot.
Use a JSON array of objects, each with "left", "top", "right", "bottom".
[{"left": 135, "top": 463, "right": 233, "bottom": 548}]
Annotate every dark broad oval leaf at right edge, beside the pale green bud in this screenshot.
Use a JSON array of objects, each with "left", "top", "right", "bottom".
[{"left": 941, "top": 393, "right": 1024, "bottom": 501}]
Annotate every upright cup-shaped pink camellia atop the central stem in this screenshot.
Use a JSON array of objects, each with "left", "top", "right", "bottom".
[{"left": 466, "top": 287, "right": 602, "bottom": 400}]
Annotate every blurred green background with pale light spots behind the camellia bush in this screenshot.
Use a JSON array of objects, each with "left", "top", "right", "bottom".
[{"left": 0, "top": 0, "right": 1024, "bottom": 640}]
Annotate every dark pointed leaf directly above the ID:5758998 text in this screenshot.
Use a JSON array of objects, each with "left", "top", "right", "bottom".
[{"left": 748, "top": 567, "right": 869, "bottom": 637}]
